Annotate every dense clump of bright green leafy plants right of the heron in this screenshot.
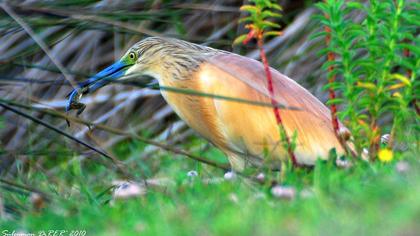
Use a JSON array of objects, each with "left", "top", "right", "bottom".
[{"left": 314, "top": 0, "right": 420, "bottom": 160}]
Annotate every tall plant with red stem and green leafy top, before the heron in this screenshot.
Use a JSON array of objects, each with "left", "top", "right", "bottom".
[{"left": 233, "top": 0, "right": 298, "bottom": 167}]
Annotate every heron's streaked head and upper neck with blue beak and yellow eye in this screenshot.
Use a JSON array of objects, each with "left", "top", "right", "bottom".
[{"left": 72, "top": 37, "right": 217, "bottom": 93}]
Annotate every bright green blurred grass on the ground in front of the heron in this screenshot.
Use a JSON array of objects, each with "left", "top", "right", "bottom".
[{"left": 0, "top": 138, "right": 420, "bottom": 235}]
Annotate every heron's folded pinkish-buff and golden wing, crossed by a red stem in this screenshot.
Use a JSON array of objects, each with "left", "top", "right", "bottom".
[{"left": 197, "top": 54, "right": 343, "bottom": 164}]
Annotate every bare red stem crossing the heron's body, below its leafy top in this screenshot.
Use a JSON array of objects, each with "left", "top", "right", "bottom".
[{"left": 257, "top": 37, "right": 299, "bottom": 167}]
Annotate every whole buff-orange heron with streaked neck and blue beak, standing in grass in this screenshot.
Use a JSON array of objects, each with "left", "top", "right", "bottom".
[{"left": 68, "top": 37, "right": 344, "bottom": 171}]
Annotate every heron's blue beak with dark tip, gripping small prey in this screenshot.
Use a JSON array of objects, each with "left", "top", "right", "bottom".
[{"left": 66, "top": 61, "right": 130, "bottom": 112}]
